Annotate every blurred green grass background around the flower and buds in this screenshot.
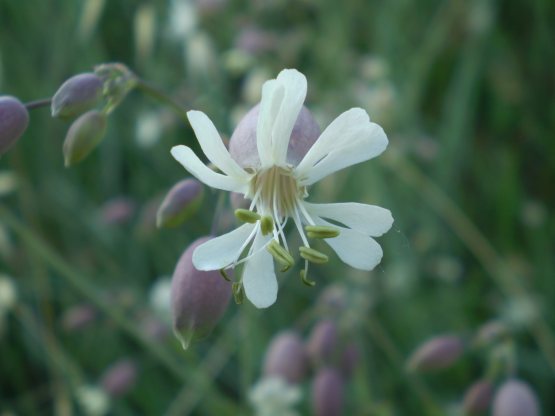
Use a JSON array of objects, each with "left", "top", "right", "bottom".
[{"left": 0, "top": 0, "right": 555, "bottom": 415}]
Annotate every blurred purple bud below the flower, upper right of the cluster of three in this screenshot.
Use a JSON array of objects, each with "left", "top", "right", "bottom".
[{"left": 306, "top": 319, "right": 338, "bottom": 366}]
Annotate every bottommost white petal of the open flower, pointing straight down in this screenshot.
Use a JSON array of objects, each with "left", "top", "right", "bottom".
[{"left": 243, "top": 233, "right": 278, "bottom": 308}]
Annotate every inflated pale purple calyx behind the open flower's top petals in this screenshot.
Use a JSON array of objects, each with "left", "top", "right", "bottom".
[{"left": 229, "top": 105, "right": 320, "bottom": 168}]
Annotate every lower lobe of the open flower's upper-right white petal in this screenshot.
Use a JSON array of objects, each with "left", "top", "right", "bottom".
[{"left": 298, "top": 123, "right": 387, "bottom": 186}]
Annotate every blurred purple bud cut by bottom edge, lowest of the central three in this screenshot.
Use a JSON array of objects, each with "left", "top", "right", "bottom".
[{"left": 312, "top": 368, "right": 344, "bottom": 416}]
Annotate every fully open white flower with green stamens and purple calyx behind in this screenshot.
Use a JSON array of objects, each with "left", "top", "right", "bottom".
[{"left": 171, "top": 69, "right": 393, "bottom": 308}]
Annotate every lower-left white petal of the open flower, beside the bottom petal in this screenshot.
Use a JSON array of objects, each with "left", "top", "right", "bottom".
[{"left": 193, "top": 224, "right": 254, "bottom": 270}]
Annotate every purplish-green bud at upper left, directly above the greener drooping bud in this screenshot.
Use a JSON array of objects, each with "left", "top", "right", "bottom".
[{"left": 51, "top": 73, "right": 102, "bottom": 118}]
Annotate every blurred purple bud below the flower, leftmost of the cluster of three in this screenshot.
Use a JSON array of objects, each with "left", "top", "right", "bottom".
[{"left": 263, "top": 331, "right": 307, "bottom": 383}]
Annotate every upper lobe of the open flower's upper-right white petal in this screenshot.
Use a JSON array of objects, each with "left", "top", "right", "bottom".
[{"left": 297, "top": 108, "right": 370, "bottom": 171}]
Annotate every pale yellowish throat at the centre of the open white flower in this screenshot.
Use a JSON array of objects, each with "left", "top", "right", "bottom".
[{"left": 250, "top": 166, "right": 305, "bottom": 218}]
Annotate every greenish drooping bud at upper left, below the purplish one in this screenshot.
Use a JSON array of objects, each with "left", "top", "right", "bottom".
[{"left": 63, "top": 110, "right": 107, "bottom": 167}]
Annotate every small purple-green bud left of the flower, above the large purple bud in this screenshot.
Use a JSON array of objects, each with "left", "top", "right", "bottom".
[{"left": 156, "top": 179, "right": 204, "bottom": 228}]
